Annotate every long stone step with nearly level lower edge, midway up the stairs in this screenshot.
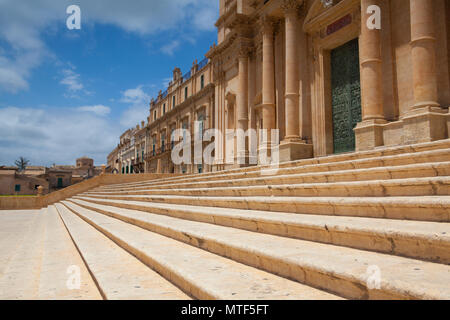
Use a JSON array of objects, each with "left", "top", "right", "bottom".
[{"left": 83, "top": 177, "right": 450, "bottom": 197}]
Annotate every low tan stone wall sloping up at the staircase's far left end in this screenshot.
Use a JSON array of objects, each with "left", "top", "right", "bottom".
[{"left": 0, "top": 173, "right": 179, "bottom": 210}]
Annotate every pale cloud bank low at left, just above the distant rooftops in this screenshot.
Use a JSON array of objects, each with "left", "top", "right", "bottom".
[{"left": 0, "top": 107, "right": 121, "bottom": 165}]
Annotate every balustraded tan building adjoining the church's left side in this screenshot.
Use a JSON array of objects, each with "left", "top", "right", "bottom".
[{"left": 145, "top": 59, "right": 214, "bottom": 173}]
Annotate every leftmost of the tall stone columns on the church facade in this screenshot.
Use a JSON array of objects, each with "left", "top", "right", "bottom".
[{"left": 236, "top": 45, "right": 249, "bottom": 166}]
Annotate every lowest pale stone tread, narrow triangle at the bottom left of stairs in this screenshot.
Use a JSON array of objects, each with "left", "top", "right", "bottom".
[{"left": 56, "top": 204, "right": 190, "bottom": 300}]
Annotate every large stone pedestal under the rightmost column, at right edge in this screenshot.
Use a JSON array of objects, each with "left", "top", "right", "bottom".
[{"left": 402, "top": 107, "right": 448, "bottom": 144}]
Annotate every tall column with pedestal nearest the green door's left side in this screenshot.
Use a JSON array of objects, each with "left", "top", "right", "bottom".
[{"left": 280, "top": 0, "right": 312, "bottom": 162}]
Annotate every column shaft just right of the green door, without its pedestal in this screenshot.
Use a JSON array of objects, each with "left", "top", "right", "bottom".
[{"left": 359, "top": 0, "right": 384, "bottom": 121}]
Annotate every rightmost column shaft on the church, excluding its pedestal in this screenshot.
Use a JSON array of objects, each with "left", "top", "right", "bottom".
[{"left": 410, "top": 0, "right": 439, "bottom": 109}]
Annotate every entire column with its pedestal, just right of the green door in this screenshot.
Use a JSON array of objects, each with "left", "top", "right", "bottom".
[{"left": 355, "top": 0, "right": 386, "bottom": 151}]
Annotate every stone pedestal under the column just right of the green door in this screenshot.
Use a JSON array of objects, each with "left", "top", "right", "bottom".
[{"left": 354, "top": 119, "right": 387, "bottom": 151}]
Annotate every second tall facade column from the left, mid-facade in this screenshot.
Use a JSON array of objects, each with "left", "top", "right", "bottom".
[{"left": 260, "top": 17, "right": 276, "bottom": 158}]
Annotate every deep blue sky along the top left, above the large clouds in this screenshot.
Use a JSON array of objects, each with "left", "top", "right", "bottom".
[{"left": 0, "top": 0, "right": 219, "bottom": 93}]
